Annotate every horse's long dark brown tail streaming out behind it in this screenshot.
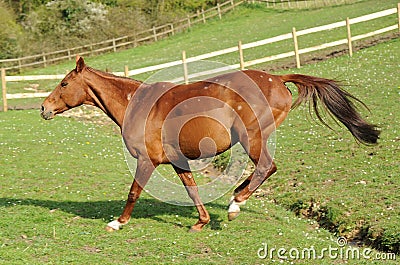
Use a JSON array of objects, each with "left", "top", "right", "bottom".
[{"left": 280, "top": 74, "right": 380, "bottom": 144}]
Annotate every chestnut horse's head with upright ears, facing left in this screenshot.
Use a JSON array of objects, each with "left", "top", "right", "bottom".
[{"left": 40, "top": 56, "right": 92, "bottom": 120}]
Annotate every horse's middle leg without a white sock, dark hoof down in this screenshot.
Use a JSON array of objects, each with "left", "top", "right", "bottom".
[{"left": 173, "top": 161, "right": 210, "bottom": 232}]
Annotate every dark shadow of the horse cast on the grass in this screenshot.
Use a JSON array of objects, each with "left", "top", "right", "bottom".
[{"left": 0, "top": 198, "right": 242, "bottom": 230}]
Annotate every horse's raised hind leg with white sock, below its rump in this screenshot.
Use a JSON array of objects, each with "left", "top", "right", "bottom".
[{"left": 228, "top": 142, "right": 276, "bottom": 221}]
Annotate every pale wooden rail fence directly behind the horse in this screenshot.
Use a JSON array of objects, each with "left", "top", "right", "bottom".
[{"left": 1, "top": 3, "right": 400, "bottom": 111}]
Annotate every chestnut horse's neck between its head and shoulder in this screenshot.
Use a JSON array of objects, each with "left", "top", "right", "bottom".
[{"left": 87, "top": 69, "right": 141, "bottom": 127}]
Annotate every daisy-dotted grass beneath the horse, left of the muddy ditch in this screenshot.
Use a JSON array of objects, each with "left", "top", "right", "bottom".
[{"left": 0, "top": 111, "right": 396, "bottom": 264}]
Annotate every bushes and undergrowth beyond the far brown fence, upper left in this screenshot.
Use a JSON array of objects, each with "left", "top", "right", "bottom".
[{"left": 0, "top": 0, "right": 217, "bottom": 59}]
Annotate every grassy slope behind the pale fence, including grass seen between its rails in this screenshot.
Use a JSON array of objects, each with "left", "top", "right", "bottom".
[{"left": 4, "top": 0, "right": 397, "bottom": 108}]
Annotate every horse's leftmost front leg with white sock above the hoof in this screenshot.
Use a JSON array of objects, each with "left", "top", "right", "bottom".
[{"left": 106, "top": 159, "right": 156, "bottom": 232}]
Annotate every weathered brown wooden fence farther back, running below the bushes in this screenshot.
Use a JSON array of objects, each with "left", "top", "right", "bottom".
[{"left": 0, "top": 0, "right": 244, "bottom": 70}]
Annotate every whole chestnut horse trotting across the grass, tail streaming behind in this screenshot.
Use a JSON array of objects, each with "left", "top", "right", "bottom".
[{"left": 41, "top": 56, "right": 380, "bottom": 231}]
